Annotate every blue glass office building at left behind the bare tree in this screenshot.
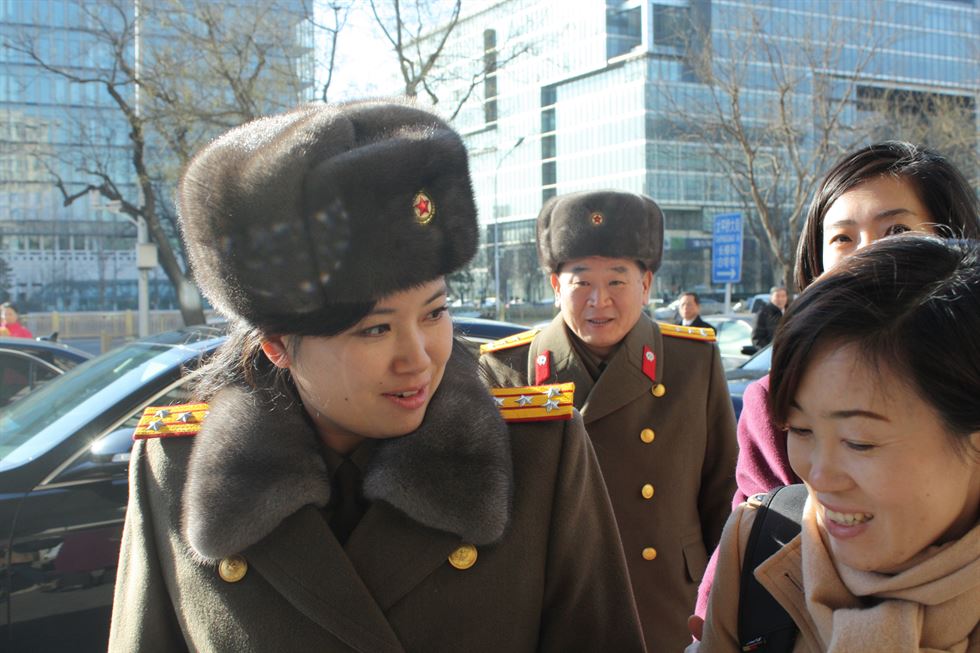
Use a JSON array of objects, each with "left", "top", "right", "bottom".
[{"left": 0, "top": 0, "right": 314, "bottom": 310}]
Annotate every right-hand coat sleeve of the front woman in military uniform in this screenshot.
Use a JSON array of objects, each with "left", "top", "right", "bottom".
[{"left": 539, "top": 411, "right": 644, "bottom": 651}]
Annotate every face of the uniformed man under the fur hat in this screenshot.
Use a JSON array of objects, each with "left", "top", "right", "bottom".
[{"left": 551, "top": 256, "right": 653, "bottom": 358}]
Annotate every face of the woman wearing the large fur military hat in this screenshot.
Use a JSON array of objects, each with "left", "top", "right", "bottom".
[{"left": 273, "top": 278, "right": 453, "bottom": 453}]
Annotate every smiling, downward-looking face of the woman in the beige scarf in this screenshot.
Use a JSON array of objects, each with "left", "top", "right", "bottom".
[{"left": 787, "top": 345, "right": 980, "bottom": 572}]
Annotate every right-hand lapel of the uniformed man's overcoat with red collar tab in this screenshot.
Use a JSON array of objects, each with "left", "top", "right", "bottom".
[{"left": 582, "top": 316, "right": 664, "bottom": 424}]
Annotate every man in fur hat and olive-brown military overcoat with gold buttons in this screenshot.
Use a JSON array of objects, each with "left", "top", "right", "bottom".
[{"left": 480, "top": 191, "right": 736, "bottom": 653}]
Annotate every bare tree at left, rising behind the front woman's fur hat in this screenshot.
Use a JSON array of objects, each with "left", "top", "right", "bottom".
[{"left": 5, "top": 0, "right": 340, "bottom": 324}]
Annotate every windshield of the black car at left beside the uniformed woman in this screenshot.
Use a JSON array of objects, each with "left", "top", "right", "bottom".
[{"left": 0, "top": 341, "right": 220, "bottom": 470}]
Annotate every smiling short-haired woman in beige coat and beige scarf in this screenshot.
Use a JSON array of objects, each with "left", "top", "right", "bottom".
[{"left": 688, "top": 234, "right": 980, "bottom": 653}]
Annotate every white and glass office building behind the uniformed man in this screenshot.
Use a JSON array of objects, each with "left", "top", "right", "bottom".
[{"left": 440, "top": 0, "right": 980, "bottom": 302}]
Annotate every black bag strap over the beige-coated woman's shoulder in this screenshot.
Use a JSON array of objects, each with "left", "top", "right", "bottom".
[{"left": 738, "top": 483, "right": 807, "bottom": 653}]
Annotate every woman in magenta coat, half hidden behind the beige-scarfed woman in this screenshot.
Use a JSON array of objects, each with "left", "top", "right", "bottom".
[{"left": 692, "top": 141, "right": 980, "bottom": 631}]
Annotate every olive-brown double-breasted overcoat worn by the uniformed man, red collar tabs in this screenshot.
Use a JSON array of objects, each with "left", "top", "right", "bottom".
[{"left": 480, "top": 315, "right": 736, "bottom": 653}]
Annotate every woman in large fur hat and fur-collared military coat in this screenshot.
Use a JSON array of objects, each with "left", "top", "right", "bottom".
[{"left": 110, "top": 103, "right": 643, "bottom": 653}]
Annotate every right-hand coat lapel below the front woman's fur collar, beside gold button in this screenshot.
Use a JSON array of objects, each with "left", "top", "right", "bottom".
[{"left": 347, "top": 502, "right": 462, "bottom": 612}]
